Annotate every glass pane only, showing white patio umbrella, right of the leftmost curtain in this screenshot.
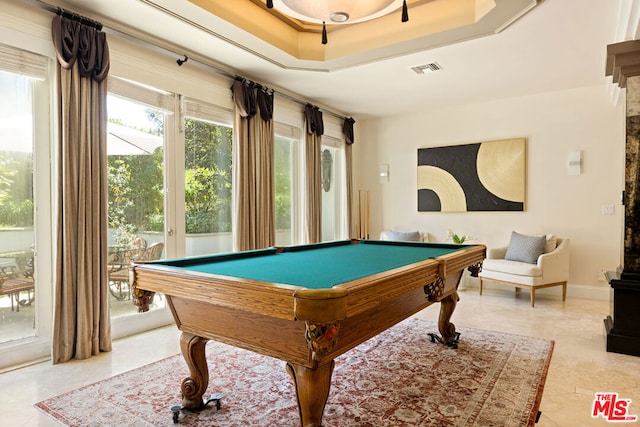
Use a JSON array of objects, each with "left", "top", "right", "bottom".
[{"left": 107, "top": 94, "right": 164, "bottom": 318}]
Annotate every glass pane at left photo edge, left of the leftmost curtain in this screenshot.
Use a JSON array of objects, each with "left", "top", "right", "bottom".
[{"left": 0, "top": 71, "right": 36, "bottom": 343}]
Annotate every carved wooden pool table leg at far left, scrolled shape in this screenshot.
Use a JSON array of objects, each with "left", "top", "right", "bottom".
[{"left": 180, "top": 332, "right": 209, "bottom": 410}]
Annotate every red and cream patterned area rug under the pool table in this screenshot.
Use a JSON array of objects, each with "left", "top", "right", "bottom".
[{"left": 35, "top": 319, "right": 554, "bottom": 427}]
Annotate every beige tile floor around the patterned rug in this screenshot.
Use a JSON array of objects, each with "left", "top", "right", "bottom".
[{"left": 0, "top": 287, "right": 640, "bottom": 427}]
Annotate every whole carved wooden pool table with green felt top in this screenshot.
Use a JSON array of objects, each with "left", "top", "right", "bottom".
[{"left": 131, "top": 240, "right": 486, "bottom": 427}]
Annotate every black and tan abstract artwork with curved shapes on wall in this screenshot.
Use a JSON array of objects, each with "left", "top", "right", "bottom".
[{"left": 418, "top": 138, "right": 526, "bottom": 212}]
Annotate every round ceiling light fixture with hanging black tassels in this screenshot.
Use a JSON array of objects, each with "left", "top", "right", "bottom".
[{"left": 267, "top": 0, "right": 409, "bottom": 44}]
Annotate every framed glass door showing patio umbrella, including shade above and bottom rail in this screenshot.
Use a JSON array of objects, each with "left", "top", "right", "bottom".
[{"left": 107, "top": 76, "right": 175, "bottom": 338}]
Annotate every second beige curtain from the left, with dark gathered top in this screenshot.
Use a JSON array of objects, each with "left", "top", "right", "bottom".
[{"left": 231, "top": 79, "right": 275, "bottom": 251}]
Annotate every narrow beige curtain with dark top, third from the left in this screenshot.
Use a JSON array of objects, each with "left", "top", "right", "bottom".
[{"left": 305, "top": 104, "right": 324, "bottom": 243}]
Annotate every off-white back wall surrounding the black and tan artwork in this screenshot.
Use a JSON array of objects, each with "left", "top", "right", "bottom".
[{"left": 354, "top": 83, "right": 625, "bottom": 289}]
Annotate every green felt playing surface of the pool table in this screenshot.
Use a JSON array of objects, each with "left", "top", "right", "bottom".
[{"left": 152, "top": 241, "right": 467, "bottom": 289}]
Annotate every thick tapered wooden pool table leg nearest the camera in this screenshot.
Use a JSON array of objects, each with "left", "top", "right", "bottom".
[{"left": 287, "top": 360, "right": 335, "bottom": 427}]
